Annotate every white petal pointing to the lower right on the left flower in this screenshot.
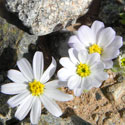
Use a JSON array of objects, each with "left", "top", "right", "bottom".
[{"left": 40, "top": 95, "right": 62, "bottom": 117}]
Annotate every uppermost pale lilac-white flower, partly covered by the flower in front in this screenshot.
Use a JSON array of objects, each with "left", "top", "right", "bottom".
[{"left": 68, "top": 21, "right": 123, "bottom": 69}]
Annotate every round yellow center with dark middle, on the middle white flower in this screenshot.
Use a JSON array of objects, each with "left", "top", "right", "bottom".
[{"left": 76, "top": 63, "right": 91, "bottom": 77}]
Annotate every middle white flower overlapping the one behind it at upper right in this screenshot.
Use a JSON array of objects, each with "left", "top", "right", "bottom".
[{"left": 57, "top": 48, "right": 108, "bottom": 96}]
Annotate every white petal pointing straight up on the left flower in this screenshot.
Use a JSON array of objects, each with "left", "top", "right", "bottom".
[{"left": 33, "top": 52, "right": 44, "bottom": 81}]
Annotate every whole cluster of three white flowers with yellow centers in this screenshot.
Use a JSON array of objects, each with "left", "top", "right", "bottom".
[{"left": 1, "top": 21, "right": 123, "bottom": 124}]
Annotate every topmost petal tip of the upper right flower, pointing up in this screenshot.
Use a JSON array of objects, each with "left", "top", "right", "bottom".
[{"left": 91, "top": 20, "right": 104, "bottom": 36}]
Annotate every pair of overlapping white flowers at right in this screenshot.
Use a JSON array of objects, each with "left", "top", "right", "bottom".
[{"left": 58, "top": 21, "right": 123, "bottom": 96}]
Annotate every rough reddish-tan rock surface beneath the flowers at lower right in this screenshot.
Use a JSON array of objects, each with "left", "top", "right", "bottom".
[{"left": 59, "top": 72, "right": 125, "bottom": 125}]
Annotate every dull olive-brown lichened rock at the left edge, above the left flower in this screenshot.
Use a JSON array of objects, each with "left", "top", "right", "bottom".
[{"left": 0, "top": 17, "right": 22, "bottom": 55}]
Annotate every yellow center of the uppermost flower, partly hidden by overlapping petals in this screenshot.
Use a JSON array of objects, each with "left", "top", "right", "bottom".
[{"left": 89, "top": 44, "right": 103, "bottom": 54}]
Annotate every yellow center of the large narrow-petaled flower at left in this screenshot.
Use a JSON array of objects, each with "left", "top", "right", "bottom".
[{"left": 29, "top": 80, "right": 45, "bottom": 96}]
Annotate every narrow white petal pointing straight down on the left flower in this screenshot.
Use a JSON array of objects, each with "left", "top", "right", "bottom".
[{"left": 30, "top": 97, "right": 41, "bottom": 124}]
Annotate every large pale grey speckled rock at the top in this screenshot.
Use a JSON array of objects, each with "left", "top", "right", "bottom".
[{"left": 6, "top": 0, "right": 92, "bottom": 35}]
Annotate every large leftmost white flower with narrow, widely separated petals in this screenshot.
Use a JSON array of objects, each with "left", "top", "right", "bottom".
[{"left": 1, "top": 52, "right": 73, "bottom": 124}]
